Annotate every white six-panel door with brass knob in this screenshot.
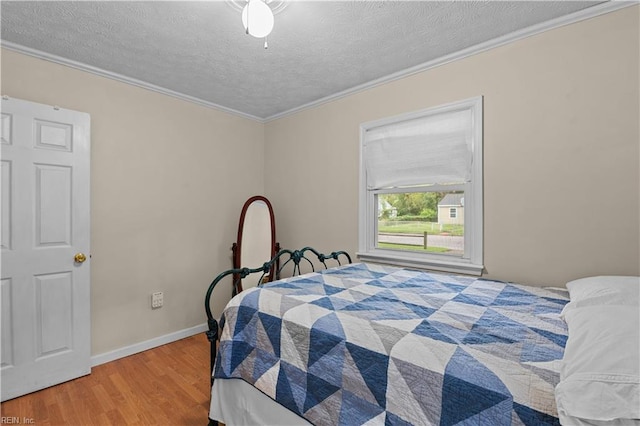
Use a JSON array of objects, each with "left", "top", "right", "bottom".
[{"left": 0, "top": 97, "right": 91, "bottom": 401}]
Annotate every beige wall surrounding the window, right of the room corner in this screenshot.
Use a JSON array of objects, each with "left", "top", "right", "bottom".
[{"left": 265, "top": 6, "right": 640, "bottom": 285}]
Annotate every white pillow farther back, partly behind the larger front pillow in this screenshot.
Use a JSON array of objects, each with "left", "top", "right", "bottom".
[{"left": 563, "top": 275, "right": 640, "bottom": 314}]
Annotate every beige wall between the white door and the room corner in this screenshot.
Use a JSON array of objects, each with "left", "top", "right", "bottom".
[{"left": 2, "top": 50, "right": 264, "bottom": 355}]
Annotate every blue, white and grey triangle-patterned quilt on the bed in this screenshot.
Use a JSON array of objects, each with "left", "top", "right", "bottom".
[{"left": 214, "top": 263, "right": 568, "bottom": 425}]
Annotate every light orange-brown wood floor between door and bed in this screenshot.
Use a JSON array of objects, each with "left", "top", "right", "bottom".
[{"left": 0, "top": 333, "right": 210, "bottom": 426}]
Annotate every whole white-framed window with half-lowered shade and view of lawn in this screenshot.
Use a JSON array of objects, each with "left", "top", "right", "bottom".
[{"left": 358, "top": 97, "right": 483, "bottom": 275}]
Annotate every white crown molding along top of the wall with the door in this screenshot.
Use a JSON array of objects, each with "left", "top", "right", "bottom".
[{"left": 0, "top": 40, "right": 265, "bottom": 123}]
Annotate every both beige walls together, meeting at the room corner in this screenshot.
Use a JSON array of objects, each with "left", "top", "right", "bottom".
[{"left": 1, "top": 6, "right": 640, "bottom": 355}]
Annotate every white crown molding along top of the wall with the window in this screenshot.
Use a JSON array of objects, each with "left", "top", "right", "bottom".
[{"left": 264, "top": 0, "right": 640, "bottom": 123}]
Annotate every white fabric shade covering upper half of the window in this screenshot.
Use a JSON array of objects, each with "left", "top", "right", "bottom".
[{"left": 363, "top": 109, "right": 473, "bottom": 190}]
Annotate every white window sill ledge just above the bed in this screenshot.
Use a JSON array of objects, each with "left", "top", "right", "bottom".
[{"left": 356, "top": 250, "right": 484, "bottom": 276}]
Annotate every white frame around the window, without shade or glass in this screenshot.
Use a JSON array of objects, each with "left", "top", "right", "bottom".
[{"left": 356, "top": 96, "right": 484, "bottom": 276}]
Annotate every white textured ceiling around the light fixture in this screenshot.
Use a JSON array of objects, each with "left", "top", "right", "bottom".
[{"left": 0, "top": 0, "right": 602, "bottom": 119}]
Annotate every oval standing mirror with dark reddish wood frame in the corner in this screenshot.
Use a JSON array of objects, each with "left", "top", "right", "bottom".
[{"left": 232, "top": 195, "right": 278, "bottom": 292}]
